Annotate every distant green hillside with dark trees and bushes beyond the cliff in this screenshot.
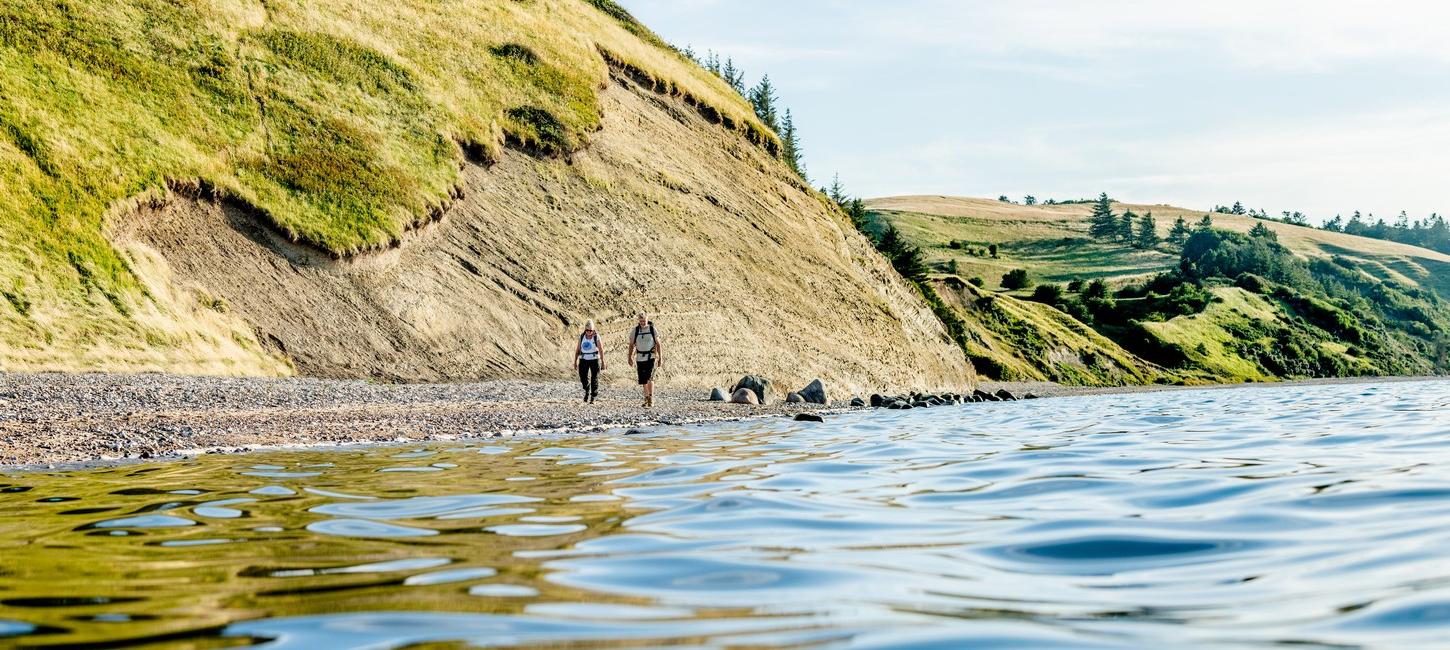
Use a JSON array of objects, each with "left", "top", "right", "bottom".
[{"left": 858, "top": 196, "right": 1450, "bottom": 386}]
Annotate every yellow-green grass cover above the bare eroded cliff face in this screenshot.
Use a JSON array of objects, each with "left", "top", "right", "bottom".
[{"left": 0, "top": 0, "right": 776, "bottom": 373}]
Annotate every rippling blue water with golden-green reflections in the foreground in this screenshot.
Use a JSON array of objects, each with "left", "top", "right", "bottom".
[{"left": 0, "top": 382, "right": 1450, "bottom": 649}]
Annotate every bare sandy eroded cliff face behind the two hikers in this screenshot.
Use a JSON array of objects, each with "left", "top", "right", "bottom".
[{"left": 113, "top": 74, "right": 973, "bottom": 390}]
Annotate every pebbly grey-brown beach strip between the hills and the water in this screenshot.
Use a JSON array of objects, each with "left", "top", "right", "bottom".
[{"left": 0, "top": 373, "right": 1446, "bottom": 472}]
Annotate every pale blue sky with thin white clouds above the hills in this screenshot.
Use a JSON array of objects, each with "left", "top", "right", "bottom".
[{"left": 621, "top": 0, "right": 1450, "bottom": 221}]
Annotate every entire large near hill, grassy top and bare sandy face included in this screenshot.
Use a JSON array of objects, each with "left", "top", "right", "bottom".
[{"left": 0, "top": 0, "right": 972, "bottom": 387}]
